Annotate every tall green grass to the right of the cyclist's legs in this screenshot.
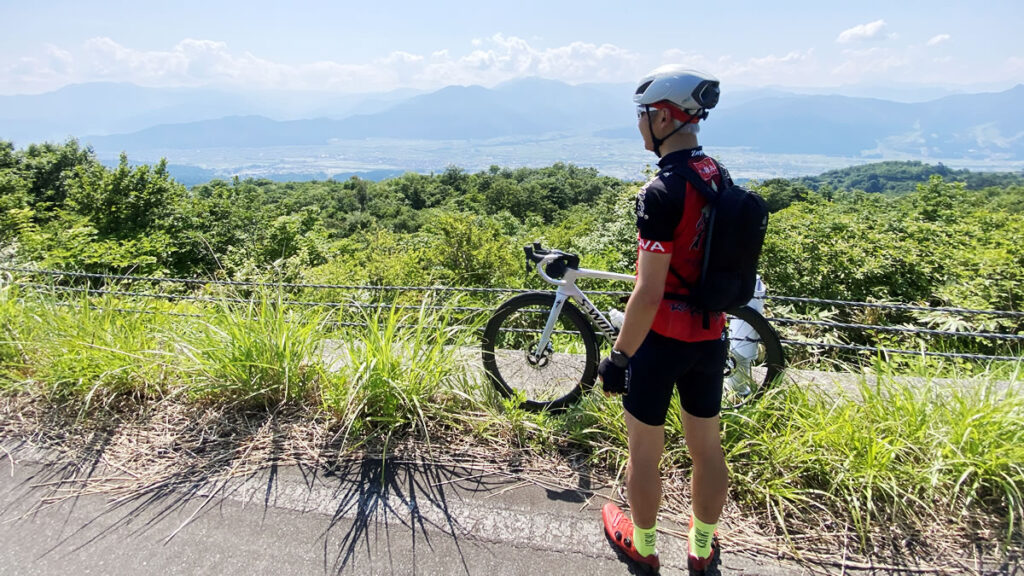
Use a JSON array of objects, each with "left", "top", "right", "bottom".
[{"left": 724, "top": 364, "right": 1024, "bottom": 549}]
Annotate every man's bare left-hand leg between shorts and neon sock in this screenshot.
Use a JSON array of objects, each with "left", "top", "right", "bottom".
[{"left": 626, "top": 411, "right": 665, "bottom": 529}]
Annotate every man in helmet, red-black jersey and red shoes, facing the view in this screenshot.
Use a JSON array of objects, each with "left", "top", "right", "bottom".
[{"left": 598, "top": 66, "right": 729, "bottom": 574}]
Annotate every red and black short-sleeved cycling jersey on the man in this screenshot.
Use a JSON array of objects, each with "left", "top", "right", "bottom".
[{"left": 636, "top": 147, "right": 725, "bottom": 342}]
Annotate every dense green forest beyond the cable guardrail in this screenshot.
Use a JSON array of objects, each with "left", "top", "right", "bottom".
[{"left": 0, "top": 140, "right": 1024, "bottom": 317}]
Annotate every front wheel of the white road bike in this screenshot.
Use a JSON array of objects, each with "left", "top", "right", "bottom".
[{"left": 482, "top": 292, "right": 600, "bottom": 411}]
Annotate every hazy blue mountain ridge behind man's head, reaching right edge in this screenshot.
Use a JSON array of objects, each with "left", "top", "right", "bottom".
[{"left": 599, "top": 85, "right": 1024, "bottom": 159}]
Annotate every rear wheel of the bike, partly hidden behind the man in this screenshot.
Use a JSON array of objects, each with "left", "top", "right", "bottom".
[{"left": 722, "top": 306, "right": 785, "bottom": 410}]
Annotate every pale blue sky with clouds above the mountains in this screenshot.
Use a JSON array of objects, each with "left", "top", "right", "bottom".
[{"left": 0, "top": 0, "right": 1024, "bottom": 96}]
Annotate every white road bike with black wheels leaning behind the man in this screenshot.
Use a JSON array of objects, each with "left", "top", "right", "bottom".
[{"left": 481, "top": 243, "right": 785, "bottom": 412}]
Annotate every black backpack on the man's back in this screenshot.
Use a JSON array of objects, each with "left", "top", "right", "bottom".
[{"left": 666, "top": 156, "right": 768, "bottom": 315}]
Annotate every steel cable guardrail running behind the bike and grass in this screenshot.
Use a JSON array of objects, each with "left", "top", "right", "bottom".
[{"left": 0, "top": 266, "right": 1024, "bottom": 362}]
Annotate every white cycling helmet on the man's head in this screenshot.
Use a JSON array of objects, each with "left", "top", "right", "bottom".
[{"left": 633, "top": 65, "right": 719, "bottom": 118}]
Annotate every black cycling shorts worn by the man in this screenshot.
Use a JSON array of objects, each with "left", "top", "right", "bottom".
[{"left": 623, "top": 330, "right": 729, "bottom": 426}]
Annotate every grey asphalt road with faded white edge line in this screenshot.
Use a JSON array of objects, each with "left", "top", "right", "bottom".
[{"left": 0, "top": 441, "right": 807, "bottom": 576}]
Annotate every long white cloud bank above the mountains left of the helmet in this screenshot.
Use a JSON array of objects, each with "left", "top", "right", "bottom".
[{"left": 0, "top": 34, "right": 638, "bottom": 91}]
